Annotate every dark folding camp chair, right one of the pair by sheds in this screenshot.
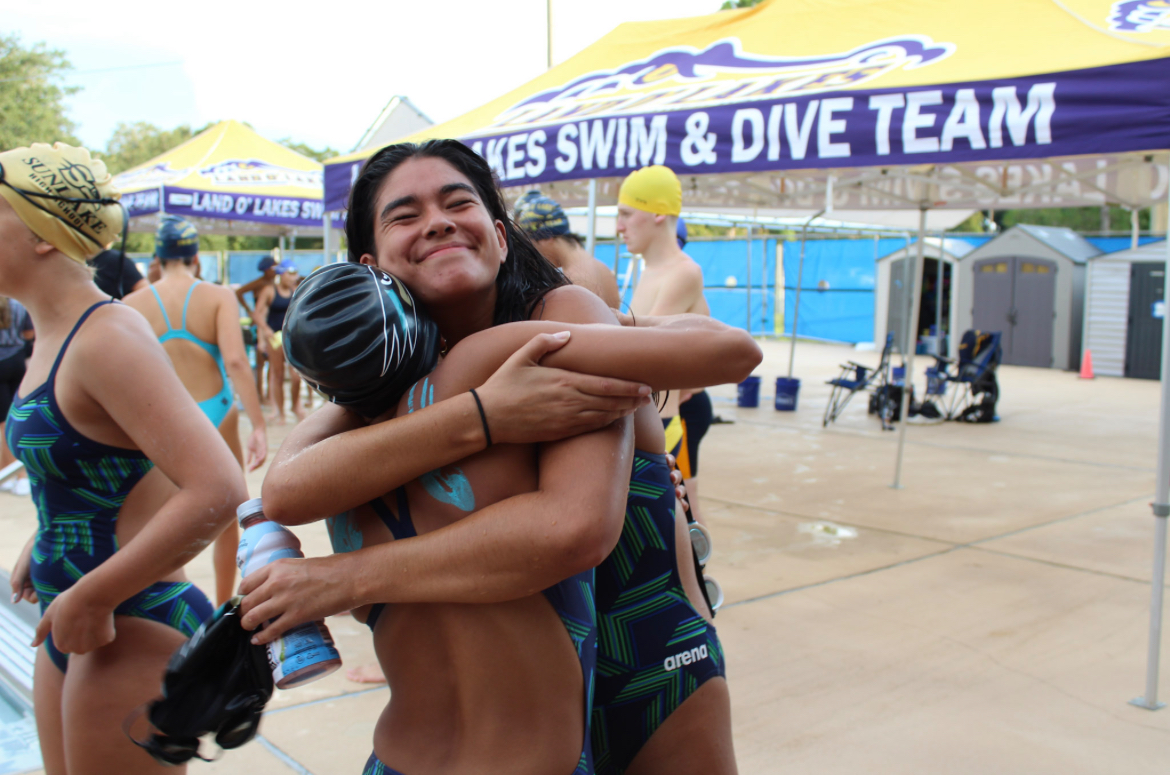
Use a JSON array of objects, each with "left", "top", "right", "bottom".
[{"left": 927, "top": 329, "right": 1003, "bottom": 423}]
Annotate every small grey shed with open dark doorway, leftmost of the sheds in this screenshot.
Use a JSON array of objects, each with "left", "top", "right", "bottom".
[{"left": 874, "top": 236, "right": 972, "bottom": 354}]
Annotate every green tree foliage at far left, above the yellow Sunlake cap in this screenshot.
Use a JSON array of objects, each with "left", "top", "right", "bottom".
[{"left": 0, "top": 35, "right": 80, "bottom": 150}]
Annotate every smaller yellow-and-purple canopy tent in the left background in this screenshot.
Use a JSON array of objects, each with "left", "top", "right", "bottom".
[{"left": 115, "top": 121, "right": 332, "bottom": 234}]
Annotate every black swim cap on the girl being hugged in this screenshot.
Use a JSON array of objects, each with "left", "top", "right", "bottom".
[{"left": 283, "top": 263, "right": 440, "bottom": 418}]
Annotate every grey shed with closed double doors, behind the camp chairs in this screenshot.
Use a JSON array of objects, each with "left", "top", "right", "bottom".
[{"left": 955, "top": 224, "right": 1101, "bottom": 369}]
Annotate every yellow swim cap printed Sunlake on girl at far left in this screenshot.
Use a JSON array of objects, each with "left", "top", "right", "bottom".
[{"left": 0, "top": 143, "right": 124, "bottom": 263}]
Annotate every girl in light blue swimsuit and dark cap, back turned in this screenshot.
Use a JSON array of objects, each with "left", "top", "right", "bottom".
[{"left": 125, "top": 215, "right": 268, "bottom": 603}]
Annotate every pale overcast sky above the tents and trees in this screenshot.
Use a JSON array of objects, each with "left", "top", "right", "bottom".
[{"left": 9, "top": 0, "right": 720, "bottom": 151}]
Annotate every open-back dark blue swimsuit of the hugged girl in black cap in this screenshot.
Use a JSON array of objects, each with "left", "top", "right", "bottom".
[{"left": 329, "top": 487, "right": 597, "bottom": 775}]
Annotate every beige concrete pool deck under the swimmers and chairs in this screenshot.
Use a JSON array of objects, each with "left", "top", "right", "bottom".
[{"left": 0, "top": 342, "right": 1170, "bottom": 775}]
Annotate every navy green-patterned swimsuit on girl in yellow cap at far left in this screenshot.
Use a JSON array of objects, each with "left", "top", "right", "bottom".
[{"left": 7, "top": 299, "right": 212, "bottom": 672}]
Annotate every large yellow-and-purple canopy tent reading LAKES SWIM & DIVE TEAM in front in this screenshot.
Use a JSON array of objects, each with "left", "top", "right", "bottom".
[{"left": 325, "top": 0, "right": 1170, "bottom": 213}]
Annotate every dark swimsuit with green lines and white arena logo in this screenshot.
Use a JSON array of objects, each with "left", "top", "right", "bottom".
[{"left": 592, "top": 450, "right": 725, "bottom": 775}]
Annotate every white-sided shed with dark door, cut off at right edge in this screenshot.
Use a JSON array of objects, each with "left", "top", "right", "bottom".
[{"left": 1085, "top": 240, "right": 1166, "bottom": 379}]
